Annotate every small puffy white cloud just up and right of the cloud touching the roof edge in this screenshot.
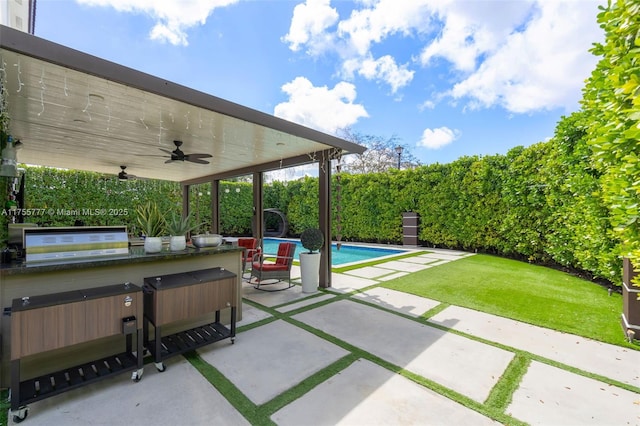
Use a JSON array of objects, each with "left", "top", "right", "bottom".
[{"left": 342, "top": 55, "right": 414, "bottom": 93}]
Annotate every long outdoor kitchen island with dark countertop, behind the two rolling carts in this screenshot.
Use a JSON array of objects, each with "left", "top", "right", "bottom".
[{"left": 0, "top": 245, "right": 242, "bottom": 388}]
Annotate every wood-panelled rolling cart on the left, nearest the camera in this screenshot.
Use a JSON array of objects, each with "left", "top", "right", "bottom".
[{"left": 11, "top": 283, "right": 143, "bottom": 423}]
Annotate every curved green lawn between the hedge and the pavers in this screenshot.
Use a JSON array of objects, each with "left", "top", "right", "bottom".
[{"left": 382, "top": 255, "right": 637, "bottom": 349}]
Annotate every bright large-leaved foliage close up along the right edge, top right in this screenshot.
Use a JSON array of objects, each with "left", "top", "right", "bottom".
[{"left": 582, "top": 0, "right": 640, "bottom": 276}]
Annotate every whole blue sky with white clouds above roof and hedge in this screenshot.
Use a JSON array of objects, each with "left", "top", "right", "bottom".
[{"left": 35, "top": 0, "right": 604, "bottom": 168}]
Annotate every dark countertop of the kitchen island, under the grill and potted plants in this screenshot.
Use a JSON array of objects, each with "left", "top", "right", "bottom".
[{"left": 0, "top": 244, "right": 242, "bottom": 277}]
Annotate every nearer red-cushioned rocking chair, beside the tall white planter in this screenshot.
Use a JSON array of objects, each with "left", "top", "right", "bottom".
[{"left": 249, "top": 243, "right": 296, "bottom": 291}]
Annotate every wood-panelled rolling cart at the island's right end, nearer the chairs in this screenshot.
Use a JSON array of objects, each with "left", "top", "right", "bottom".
[{"left": 143, "top": 268, "right": 237, "bottom": 371}]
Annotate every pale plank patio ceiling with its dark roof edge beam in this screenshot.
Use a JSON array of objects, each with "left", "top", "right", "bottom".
[{"left": 0, "top": 25, "right": 365, "bottom": 183}]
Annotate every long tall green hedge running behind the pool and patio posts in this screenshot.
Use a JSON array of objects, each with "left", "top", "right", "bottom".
[{"left": 8, "top": 112, "right": 621, "bottom": 283}]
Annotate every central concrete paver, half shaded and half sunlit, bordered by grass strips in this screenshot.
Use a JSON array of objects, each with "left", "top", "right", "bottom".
[{"left": 293, "top": 300, "right": 513, "bottom": 402}]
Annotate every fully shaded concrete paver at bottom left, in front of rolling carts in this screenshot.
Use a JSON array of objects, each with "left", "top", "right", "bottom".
[{"left": 16, "top": 357, "right": 249, "bottom": 426}]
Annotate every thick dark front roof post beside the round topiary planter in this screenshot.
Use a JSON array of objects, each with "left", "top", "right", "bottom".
[{"left": 318, "top": 151, "right": 332, "bottom": 288}]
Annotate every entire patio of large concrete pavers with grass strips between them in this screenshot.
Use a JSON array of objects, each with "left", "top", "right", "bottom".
[{"left": 9, "top": 250, "right": 640, "bottom": 426}]
